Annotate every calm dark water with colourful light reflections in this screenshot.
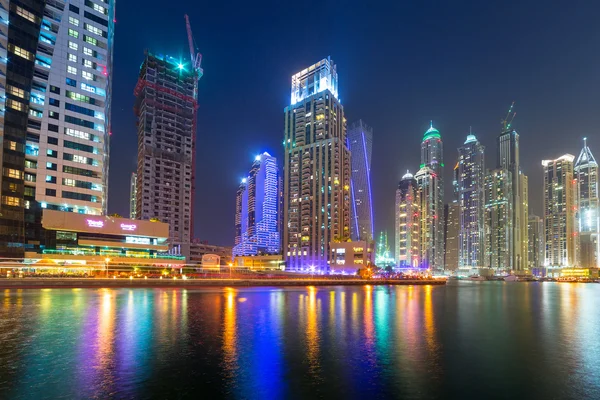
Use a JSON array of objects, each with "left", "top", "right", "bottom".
[{"left": 0, "top": 282, "right": 600, "bottom": 399}]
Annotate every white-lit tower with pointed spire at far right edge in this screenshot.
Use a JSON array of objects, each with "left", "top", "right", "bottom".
[{"left": 575, "top": 138, "right": 600, "bottom": 268}]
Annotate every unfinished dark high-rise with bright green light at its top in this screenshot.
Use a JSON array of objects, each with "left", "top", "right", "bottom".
[{"left": 134, "top": 52, "right": 201, "bottom": 243}]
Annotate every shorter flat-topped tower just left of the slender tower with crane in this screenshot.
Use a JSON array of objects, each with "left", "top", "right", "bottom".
[{"left": 484, "top": 169, "right": 514, "bottom": 272}]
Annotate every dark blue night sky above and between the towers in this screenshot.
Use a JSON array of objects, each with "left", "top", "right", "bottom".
[{"left": 109, "top": 0, "right": 600, "bottom": 245}]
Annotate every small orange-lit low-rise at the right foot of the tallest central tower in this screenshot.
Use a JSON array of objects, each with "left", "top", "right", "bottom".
[{"left": 328, "top": 240, "right": 375, "bottom": 274}]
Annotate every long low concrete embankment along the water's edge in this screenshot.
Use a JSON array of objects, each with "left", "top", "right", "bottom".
[{"left": 0, "top": 278, "right": 446, "bottom": 289}]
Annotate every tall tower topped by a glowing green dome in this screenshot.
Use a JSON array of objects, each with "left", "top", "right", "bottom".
[{"left": 415, "top": 123, "right": 444, "bottom": 270}]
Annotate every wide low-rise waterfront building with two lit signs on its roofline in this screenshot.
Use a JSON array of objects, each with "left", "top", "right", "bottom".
[{"left": 24, "top": 209, "right": 185, "bottom": 274}]
